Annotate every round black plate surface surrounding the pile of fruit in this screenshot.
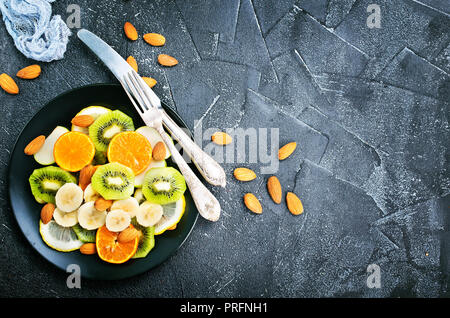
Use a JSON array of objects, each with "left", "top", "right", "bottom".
[{"left": 8, "top": 84, "right": 198, "bottom": 280}]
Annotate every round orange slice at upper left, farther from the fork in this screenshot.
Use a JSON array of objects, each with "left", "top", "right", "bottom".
[{"left": 53, "top": 131, "right": 95, "bottom": 172}]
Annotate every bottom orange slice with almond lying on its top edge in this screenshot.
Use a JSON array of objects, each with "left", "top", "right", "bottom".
[{"left": 95, "top": 225, "right": 139, "bottom": 264}]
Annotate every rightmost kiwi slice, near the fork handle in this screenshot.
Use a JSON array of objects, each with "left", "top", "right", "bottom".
[{"left": 142, "top": 167, "right": 186, "bottom": 205}]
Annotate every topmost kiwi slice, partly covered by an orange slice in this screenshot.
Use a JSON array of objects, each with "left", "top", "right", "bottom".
[{"left": 89, "top": 110, "right": 134, "bottom": 152}]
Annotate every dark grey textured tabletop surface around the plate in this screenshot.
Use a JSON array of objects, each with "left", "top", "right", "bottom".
[{"left": 0, "top": 0, "right": 450, "bottom": 297}]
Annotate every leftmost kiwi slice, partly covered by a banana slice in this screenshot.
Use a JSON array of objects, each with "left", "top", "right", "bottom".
[{"left": 28, "top": 166, "right": 77, "bottom": 203}]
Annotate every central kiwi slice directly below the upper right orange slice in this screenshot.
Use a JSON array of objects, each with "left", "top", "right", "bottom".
[{"left": 91, "top": 162, "right": 134, "bottom": 200}]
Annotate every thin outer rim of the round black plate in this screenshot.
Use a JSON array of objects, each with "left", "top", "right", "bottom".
[{"left": 6, "top": 83, "right": 199, "bottom": 281}]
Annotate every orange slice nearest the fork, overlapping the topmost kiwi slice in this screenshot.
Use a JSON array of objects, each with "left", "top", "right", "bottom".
[{"left": 106, "top": 131, "right": 152, "bottom": 176}]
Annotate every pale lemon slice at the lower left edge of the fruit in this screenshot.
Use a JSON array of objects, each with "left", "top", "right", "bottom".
[{"left": 39, "top": 220, "right": 83, "bottom": 252}]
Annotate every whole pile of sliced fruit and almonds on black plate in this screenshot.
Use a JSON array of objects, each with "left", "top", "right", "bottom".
[{"left": 25, "top": 106, "right": 186, "bottom": 264}]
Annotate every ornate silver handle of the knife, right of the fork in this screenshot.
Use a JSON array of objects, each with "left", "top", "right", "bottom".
[{"left": 161, "top": 109, "right": 226, "bottom": 187}]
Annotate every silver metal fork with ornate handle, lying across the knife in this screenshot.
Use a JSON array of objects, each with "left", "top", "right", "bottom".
[{"left": 119, "top": 71, "right": 220, "bottom": 221}]
